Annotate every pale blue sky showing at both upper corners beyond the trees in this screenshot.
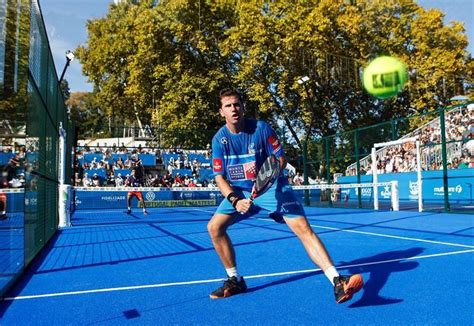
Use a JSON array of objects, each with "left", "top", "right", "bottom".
[{"left": 39, "top": 0, "right": 474, "bottom": 92}]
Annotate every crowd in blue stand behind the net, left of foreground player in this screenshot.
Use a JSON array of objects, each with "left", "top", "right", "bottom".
[{"left": 75, "top": 143, "right": 213, "bottom": 187}]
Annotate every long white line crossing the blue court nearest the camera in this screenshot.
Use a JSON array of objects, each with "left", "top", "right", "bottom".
[{"left": 4, "top": 250, "right": 474, "bottom": 301}]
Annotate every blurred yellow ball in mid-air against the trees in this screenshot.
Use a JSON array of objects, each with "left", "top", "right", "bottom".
[{"left": 363, "top": 56, "right": 408, "bottom": 99}]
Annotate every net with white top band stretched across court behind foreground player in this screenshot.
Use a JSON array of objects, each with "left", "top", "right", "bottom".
[{"left": 51, "top": 181, "right": 399, "bottom": 227}]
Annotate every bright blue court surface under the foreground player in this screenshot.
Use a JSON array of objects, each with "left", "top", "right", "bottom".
[{"left": 0, "top": 207, "right": 474, "bottom": 325}]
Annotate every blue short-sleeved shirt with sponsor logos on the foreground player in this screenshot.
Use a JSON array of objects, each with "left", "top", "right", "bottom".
[{"left": 212, "top": 119, "right": 283, "bottom": 191}]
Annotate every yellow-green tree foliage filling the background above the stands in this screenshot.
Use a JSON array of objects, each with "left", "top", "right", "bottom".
[{"left": 76, "top": 0, "right": 473, "bottom": 147}]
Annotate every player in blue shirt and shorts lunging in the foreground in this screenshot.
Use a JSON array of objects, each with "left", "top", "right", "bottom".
[{"left": 208, "top": 89, "right": 364, "bottom": 303}]
